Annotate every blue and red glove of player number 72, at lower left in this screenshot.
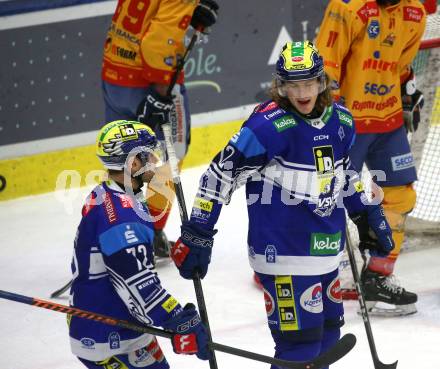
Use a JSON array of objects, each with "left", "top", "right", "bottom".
[{"left": 163, "top": 304, "right": 210, "bottom": 360}]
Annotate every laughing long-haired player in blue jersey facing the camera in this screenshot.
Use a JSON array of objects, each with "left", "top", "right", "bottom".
[{"left": 171, "top": 41, "right": 394, "bottom": 368}]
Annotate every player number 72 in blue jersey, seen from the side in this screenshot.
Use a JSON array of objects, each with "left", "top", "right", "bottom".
[{"left": 69, "top": 120, "right": 209, "bottom": 369}]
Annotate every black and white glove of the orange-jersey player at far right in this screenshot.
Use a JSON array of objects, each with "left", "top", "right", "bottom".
[{"left": 400, "top": 69, "right": 425, "bottom": 132}]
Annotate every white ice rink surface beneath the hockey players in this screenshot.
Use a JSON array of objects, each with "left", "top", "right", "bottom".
[{"left": 0, "top": 168, "right": 440, "bottom": 369}]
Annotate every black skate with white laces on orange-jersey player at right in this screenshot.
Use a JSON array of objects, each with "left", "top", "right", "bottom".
[{"left": 361, "top": 269, "right": 417, "bottom": 317}]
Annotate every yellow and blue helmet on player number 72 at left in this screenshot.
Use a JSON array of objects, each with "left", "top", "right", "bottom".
[{"left": 96, "top": 120, "right": 163, "bottom": 170}]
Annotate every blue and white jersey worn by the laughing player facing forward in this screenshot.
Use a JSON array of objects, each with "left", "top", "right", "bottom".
[{"left": 191, "top": 101, "right": 367, "bottom": 275}]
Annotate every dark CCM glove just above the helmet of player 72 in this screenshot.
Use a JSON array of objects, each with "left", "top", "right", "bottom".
[{"left": 137, "top": 86, "right": 174, "bottom": 131}]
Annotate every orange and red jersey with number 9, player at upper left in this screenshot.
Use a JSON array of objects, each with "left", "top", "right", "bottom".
[{"left": 102, "top": 0, "right": 198, "bottom": 87}]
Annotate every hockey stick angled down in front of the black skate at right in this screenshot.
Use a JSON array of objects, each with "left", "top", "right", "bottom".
[{"left": 346, "top": 227, "right": 397, "bottom": 369}]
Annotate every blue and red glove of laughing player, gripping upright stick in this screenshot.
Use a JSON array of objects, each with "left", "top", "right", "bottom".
[{"left": 171, "top": 222, "right": 217, "bottom": 279}]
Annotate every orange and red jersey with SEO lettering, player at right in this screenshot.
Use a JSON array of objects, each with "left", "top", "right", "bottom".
[{"left": 316, "top": 0, "right": 426, "bottom": 133}]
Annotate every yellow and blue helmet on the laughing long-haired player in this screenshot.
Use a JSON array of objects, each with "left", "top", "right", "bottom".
[{"left": 275, "top": 41, "right": 324, "bottom": 82}]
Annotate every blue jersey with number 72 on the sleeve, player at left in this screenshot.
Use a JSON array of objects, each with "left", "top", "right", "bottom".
[{"left": 69, "top": 181, "right": 182, "bottom": 361}]
